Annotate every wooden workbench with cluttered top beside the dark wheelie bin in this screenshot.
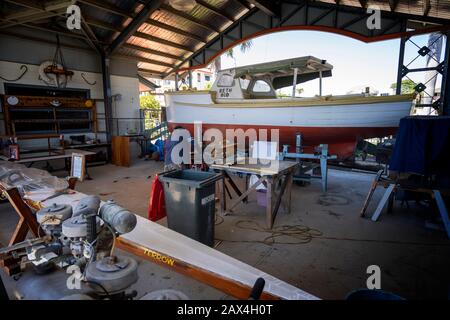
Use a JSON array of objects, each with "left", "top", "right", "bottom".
[{"left": 210, "top": 158, "right": 298, "bottom": 229}]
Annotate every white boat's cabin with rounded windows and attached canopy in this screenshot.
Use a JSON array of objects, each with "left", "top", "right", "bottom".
[{"left": 210, "top": 56, "right": 333, "bottom": 100}]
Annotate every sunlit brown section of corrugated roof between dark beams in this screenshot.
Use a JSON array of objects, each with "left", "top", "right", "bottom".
[{"left": 120, "top": 0, "right": 248, "bottom": 73}]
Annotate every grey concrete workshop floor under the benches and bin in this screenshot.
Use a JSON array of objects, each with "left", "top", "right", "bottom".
[{"left": 0, "top": 160, "right": 450, "bottom": 299}]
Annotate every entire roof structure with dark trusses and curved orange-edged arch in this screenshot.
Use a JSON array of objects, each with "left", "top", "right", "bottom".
[{"left": 0, "top": 0, "right": 450, "bottom": 76}]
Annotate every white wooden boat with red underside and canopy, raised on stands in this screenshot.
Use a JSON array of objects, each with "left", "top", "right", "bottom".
[{"left": 165, "top": 56, "right": 414, "bottom": 159}]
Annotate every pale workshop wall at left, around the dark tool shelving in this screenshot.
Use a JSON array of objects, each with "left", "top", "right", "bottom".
[{"left": 0, "top": 35, "right": 139, "bottom": 140}]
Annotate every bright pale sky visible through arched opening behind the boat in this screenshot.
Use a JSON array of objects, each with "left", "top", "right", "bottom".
[{"left": 218, "top": 30, "right": 440, "bottom": 96}]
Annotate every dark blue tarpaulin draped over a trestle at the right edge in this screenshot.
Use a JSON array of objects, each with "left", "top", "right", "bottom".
[{"left": 389, "top": 116, "right": 450, "bottom": 176}]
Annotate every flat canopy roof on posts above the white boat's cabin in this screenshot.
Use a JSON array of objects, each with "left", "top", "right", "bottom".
[{"left": 219, "top": 56, "right": 333, "bottom": 89}]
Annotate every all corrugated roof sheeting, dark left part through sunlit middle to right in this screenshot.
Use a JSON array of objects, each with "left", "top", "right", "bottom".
[{"left": 0, "top": 0, "right": 450, "bottom": 79}]
